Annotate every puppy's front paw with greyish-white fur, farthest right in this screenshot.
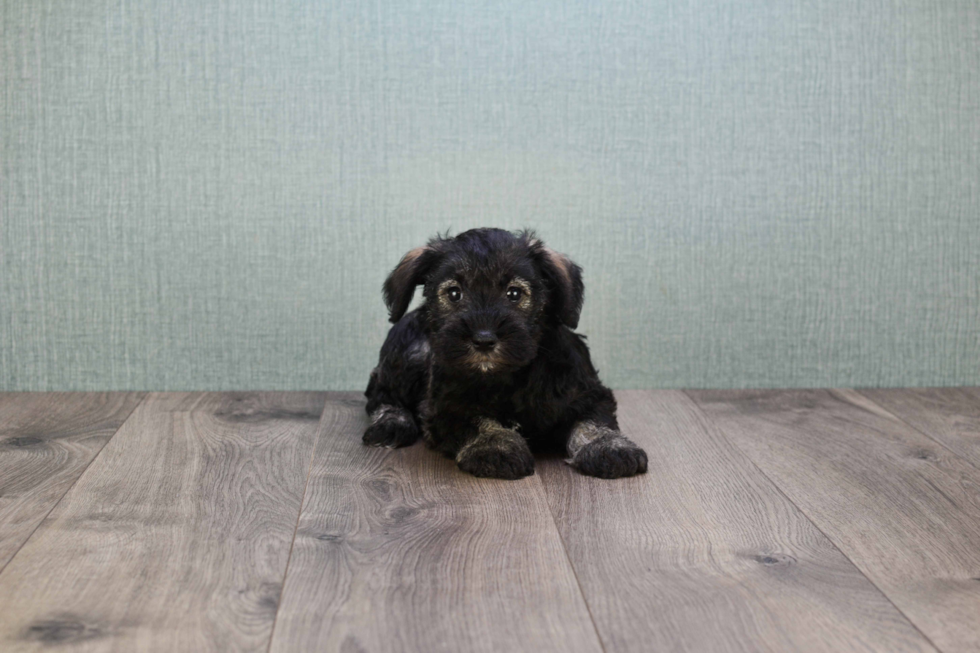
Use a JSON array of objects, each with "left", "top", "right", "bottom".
[{"left": 565, "top": 420, "right": 647, "bottom": 478}]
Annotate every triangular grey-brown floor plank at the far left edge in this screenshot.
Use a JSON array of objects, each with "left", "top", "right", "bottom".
[{"left": 0, "top": 392, "right": 143, "bottom": 571}]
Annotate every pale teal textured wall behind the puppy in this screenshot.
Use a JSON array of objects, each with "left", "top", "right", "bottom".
[{"left": 0, "top": 0, "right": 980, "bottom": 390}]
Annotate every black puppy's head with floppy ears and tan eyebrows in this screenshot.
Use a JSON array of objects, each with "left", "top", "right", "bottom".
[{"left": 384, "top": 229, "right": 585, "bottom": 375}]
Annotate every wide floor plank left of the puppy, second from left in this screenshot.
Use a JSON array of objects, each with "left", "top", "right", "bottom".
[{"left": 0, "top": 393, "right": 325, "bottom": 651}]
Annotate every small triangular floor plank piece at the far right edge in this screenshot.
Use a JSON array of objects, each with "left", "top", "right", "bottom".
[{"left": 859, "top": 388, "right": 980, "bottom": 467}]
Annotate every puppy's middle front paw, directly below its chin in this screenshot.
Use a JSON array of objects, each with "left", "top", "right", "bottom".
[{"left": 456, "top": 417, "right": 534, "bottom": 479}]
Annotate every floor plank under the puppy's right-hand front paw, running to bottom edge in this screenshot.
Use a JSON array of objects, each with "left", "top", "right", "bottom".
[{"left": 540, "top": 391, "right": 934, "bottom": 653}]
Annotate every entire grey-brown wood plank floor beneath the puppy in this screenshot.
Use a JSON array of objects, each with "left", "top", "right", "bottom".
[{"left": 0, "top": 388, "right": 980, "bottom": 653}]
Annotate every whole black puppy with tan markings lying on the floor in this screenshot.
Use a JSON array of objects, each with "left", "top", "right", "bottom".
[{"left": 364, "top": 229, "right": 647, "bottom": 479}]
